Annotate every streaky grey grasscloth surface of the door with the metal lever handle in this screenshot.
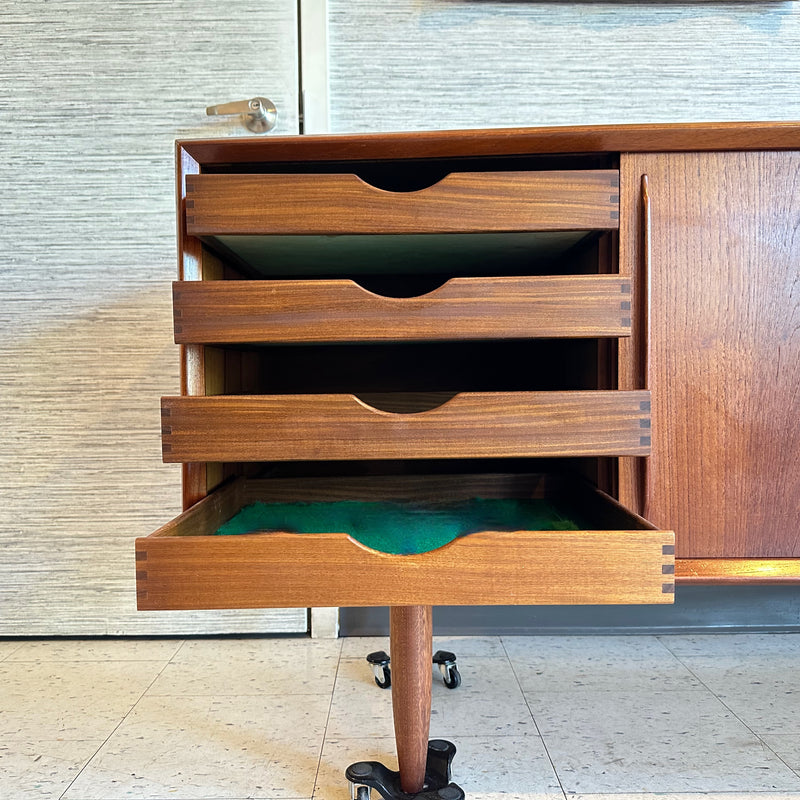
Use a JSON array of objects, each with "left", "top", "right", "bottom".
[{"left": 0, "top": 0, "right": 305, "bottom": 635}]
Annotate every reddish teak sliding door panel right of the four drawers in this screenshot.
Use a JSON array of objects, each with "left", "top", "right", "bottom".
[{"left": 620, "top": 152, "right": 800, "bottom": 558}]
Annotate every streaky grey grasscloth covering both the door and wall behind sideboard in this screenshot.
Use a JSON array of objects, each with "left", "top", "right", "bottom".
[{"left": 0, "top": 0, "right": 800, "bottom": 636}]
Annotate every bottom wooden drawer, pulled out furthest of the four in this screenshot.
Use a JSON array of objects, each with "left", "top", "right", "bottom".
[{"left": 136, "top": 475, "right": 674, "bottom": 610}]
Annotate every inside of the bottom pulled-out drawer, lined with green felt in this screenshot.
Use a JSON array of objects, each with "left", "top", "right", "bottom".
[{"left": 167, "top": 472, "right": 654, "bottom": 540}]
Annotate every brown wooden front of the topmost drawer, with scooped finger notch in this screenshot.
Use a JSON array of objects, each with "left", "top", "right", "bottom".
[{"left": 186, "top": 170, "right": 619, "bottom": 236}]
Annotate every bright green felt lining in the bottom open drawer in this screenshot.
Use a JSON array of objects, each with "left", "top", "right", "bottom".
[{"left": 216, "top": 498, "right": 579, "bottom": 555}]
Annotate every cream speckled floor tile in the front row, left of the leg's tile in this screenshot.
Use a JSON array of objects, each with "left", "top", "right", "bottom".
[{"left": 59, "top": 696, "right": 329, "bottom": 800}]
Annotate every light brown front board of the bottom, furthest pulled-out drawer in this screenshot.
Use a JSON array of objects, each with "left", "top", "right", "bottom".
[{"left": 137, "top": 531, "right": 674, "bottom": 610}]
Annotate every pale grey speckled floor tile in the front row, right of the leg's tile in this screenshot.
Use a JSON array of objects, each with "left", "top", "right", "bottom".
[{"left": 526, "top": 691, "right": 800, "bottom": 794}]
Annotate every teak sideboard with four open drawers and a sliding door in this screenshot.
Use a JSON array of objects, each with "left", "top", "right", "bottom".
[{"left": 136, "top": 123, "right": 800, "bottom": 791}]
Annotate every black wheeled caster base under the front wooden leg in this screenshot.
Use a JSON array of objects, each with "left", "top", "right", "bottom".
[{"left": 344, "top": 739, "right": 464, "bottom": 800}]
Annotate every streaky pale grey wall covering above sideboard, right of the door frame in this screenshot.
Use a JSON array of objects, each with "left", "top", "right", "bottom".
[{"left": 329, "top": 0, "right": 800, "bottom": 132}]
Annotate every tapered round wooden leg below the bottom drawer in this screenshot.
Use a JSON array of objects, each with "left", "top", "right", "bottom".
[{"left": 389, "top": 606, "right": 433, "bottom": 794}]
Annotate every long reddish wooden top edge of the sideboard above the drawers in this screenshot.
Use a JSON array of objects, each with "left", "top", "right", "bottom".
[{"left": 176, "top": 122, "right": 800, "bottom": 167}]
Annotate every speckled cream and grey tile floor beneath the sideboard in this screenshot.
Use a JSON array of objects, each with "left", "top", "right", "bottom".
[{"left": 0, "top": 634, "right": 800, "bottom": 800}]
